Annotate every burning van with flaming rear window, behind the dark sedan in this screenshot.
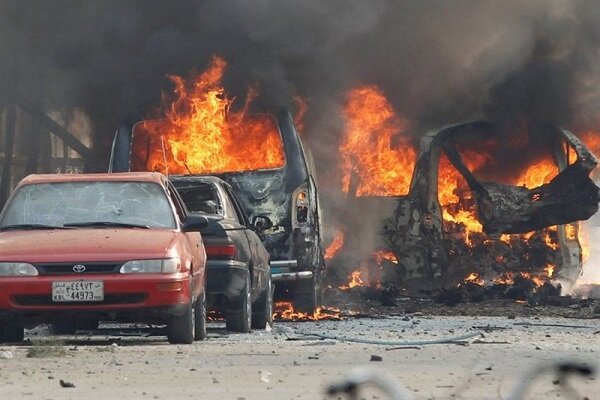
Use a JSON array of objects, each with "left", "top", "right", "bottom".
[{"left": 110, "top": 110, "right": 325, "bottom": 312}]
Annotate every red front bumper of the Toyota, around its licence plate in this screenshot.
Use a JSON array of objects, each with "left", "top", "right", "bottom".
[{"left": 0, "top": 273, "right": 191, "bottom": 323}]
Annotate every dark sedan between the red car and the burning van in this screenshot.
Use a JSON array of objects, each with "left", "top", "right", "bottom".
[{"left": 169, "top": 176, "right": 273, "bottom": 332}]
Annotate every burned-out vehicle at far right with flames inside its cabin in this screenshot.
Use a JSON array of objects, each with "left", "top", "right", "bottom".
[{"left": 384, "top": 121, "right": 599, "bottom": 285}]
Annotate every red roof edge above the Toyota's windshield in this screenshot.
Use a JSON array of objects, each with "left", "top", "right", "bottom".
[{"left": 19, "top": 172, "right": 165, "bottom": 186}]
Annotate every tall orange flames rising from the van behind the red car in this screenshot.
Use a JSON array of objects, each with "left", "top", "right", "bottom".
[{"left": 133, "top": 56, "right": 285, "bottom": 174}]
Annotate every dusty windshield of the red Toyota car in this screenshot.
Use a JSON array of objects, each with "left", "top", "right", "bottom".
[{"left": 0, "top": 182, "right": 176, "bottom": 228}]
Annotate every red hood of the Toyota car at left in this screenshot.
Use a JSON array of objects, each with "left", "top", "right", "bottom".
[{"left": 0, "top": 229, "right": 178, "bottom": 263}]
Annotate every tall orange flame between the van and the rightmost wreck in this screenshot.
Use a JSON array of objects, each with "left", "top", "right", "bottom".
[{"left": 340, "top": 86, "right": 416, "bottom": 196}]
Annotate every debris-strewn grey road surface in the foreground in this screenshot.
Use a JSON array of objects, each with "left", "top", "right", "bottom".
[{"left": 0, "top": 316, "right": 600, "bottom": 400}]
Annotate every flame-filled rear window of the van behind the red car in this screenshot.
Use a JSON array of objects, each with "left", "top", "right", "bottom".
[{"left": 130, "top": 114, "right": 285, "bottom": 174}]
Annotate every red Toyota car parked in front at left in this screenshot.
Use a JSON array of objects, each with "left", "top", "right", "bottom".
[{"left": 0, "top": 172, "right": 207, "bottom": 343}]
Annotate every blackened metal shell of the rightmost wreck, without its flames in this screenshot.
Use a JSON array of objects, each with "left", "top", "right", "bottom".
[{"left": 380, "top": 121, "right": 599, "bottom": 286}]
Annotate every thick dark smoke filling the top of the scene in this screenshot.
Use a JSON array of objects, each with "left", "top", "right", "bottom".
[{"left": 0, "top": 0, "right": 600, "bottom": 170}]
